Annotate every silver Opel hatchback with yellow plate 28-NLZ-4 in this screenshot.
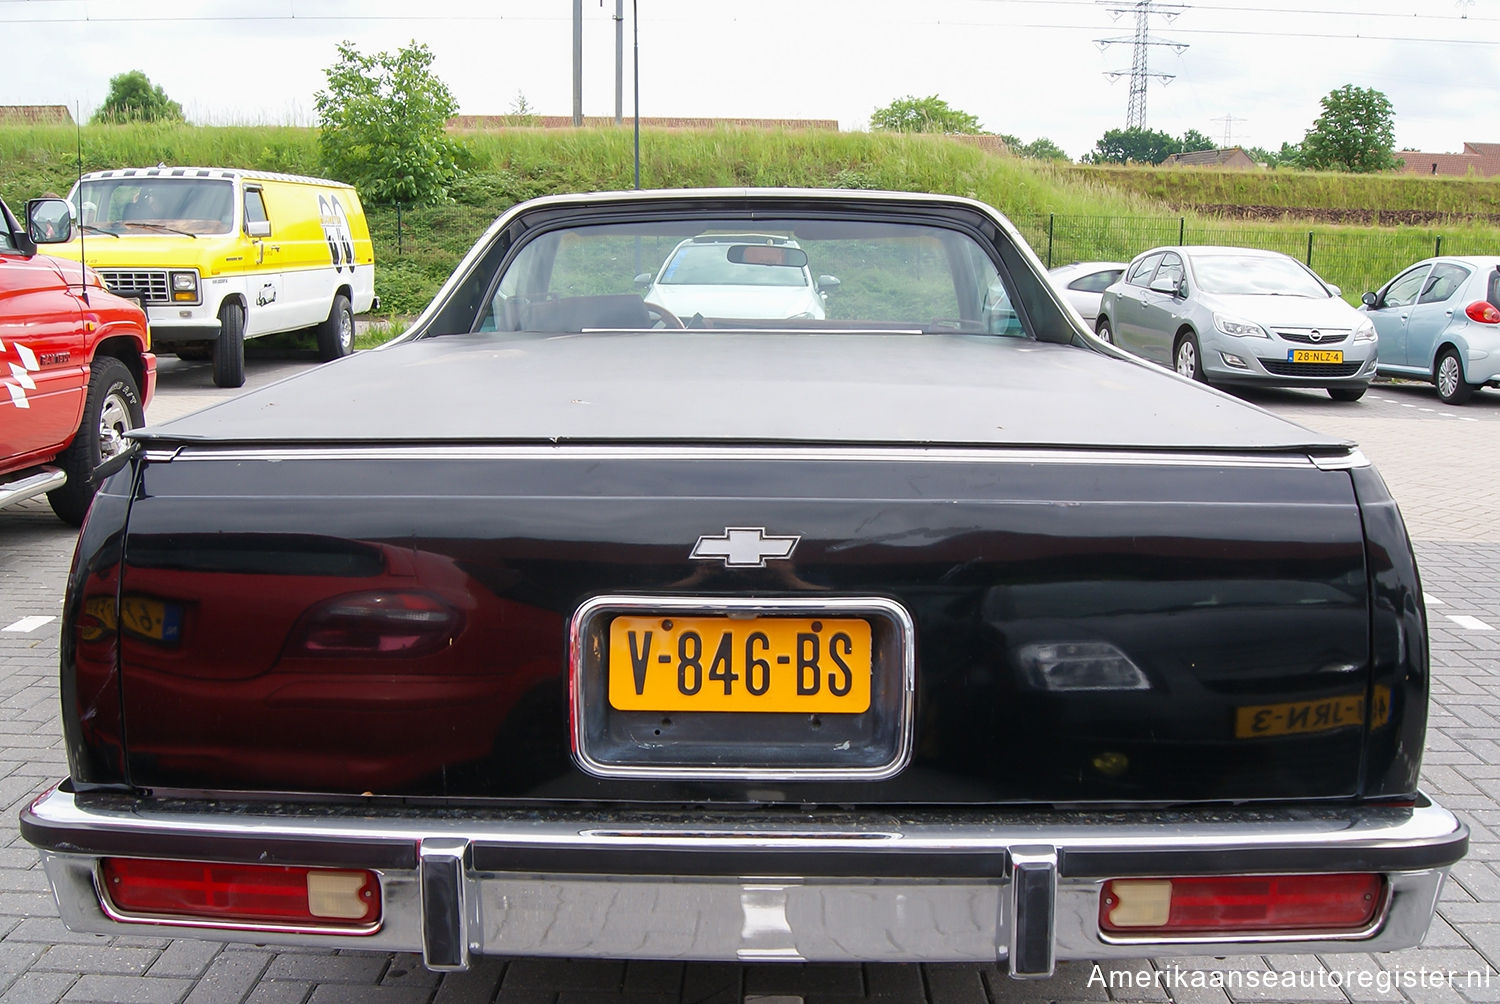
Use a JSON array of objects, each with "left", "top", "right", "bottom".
[{"left": 1095, "top": 246, "right": 1377, "bottom": 401}]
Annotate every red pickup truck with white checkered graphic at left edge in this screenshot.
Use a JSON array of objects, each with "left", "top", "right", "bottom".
[{"left": 0, "top": 193, "right": 156, "bottom": 525}]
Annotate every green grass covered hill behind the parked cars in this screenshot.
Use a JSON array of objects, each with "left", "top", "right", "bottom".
[{"left": 0, "top": 125, "right": 1500, "bottom": 314}]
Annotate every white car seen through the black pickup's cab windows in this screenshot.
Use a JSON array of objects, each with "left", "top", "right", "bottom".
[{"left": 636, "top": 234, "right": 839, "bottom": 323}]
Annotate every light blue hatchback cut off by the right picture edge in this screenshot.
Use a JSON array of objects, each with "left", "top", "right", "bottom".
[{"left": 1362, "top": 257, "right": 1500, "bottom": 404}]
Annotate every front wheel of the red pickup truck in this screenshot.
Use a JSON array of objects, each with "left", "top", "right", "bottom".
[{"left": 47, "top": 356, "right": 146, "bottom": 527}]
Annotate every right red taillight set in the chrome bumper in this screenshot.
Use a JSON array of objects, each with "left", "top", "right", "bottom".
[{"left": 1100, "top": 873, "right": 1385, "bottom": 935}]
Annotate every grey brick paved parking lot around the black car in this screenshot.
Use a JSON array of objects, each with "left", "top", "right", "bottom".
[{"left": 0, "top": 360, "right": 1500, "bottom": 1004}]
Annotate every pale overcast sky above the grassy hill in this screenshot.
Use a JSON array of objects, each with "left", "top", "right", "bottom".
[{"left": 0, "top": 0, "right": 1500, "bottom": 159}]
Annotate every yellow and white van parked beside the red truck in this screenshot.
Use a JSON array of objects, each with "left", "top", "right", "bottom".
[{"left": 48, "top": 167, "right": 378, "bottom": 387}]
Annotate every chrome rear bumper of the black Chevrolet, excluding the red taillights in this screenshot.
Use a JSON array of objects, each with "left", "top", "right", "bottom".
[{"left": 21, "top": 788, "right": 1469, "bottom": 977}]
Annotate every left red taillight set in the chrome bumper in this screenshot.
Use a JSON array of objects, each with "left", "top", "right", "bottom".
[{"left": 99, "top": 857, "right": 381, "bottom": 933}]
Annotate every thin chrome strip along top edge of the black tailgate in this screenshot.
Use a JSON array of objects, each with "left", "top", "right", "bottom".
[{"left": 147, "top": 443, "right": 1326, "bottom": 470}]
